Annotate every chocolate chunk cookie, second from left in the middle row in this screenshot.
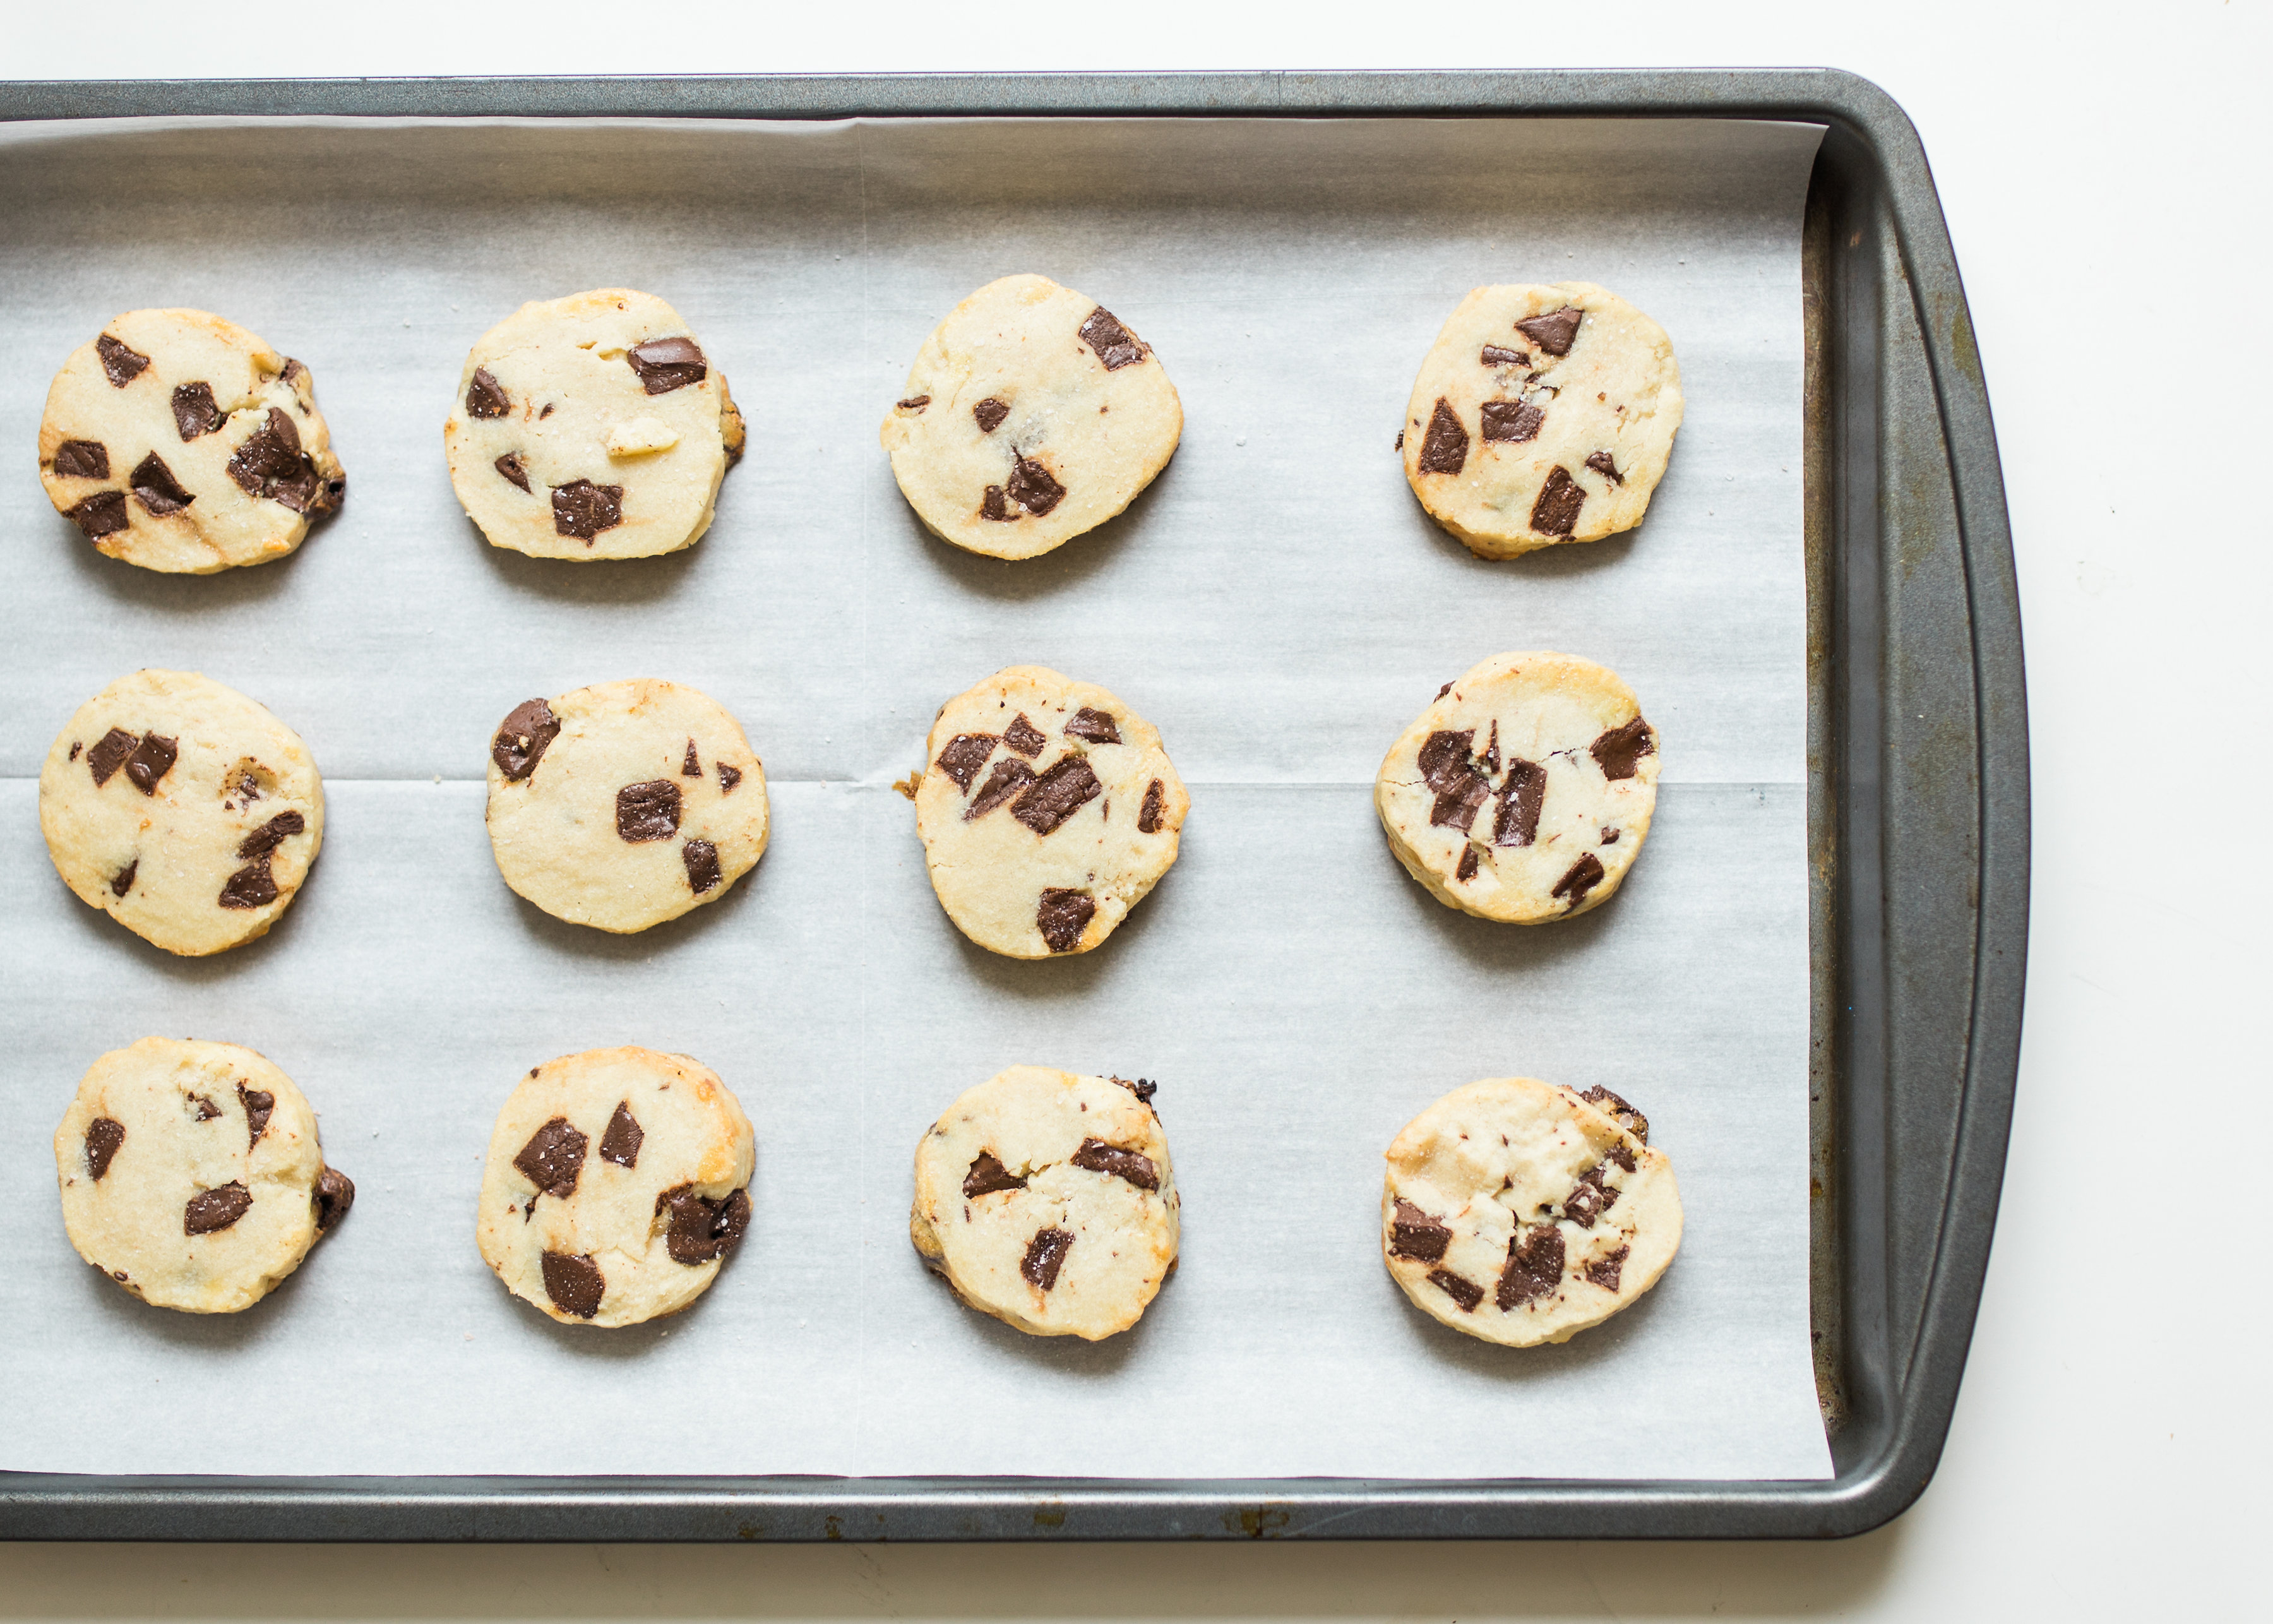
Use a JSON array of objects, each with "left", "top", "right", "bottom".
[{"left": 489, "top": 678, "right": 766, "bottom": 935}]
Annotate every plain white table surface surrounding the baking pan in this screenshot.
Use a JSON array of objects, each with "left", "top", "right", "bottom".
[{"left": 0, "top": 0, "right": 2273, "bottom": 1620}]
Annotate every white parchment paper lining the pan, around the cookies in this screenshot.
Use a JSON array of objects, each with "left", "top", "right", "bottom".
[{"left": 0, "top": 121, "right": 1830, "bottom": 1478}]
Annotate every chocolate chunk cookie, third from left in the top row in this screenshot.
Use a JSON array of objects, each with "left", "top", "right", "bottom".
[{"left": 882, "top": 275, "right": 1184, "bottom": 558}]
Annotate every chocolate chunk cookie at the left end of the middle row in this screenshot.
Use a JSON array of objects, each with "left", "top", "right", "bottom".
[{"left": 39, "top": 671, "right": 323, "bottom": 958}]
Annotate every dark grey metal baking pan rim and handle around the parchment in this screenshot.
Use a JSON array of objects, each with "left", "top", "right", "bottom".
[{"left": 0, "top": 71, "right": 2027, "bottom": 1540}]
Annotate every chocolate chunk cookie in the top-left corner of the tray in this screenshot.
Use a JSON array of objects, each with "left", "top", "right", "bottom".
[{"left": 39, "top": 309, "right": 348, "bottom": 575}]
